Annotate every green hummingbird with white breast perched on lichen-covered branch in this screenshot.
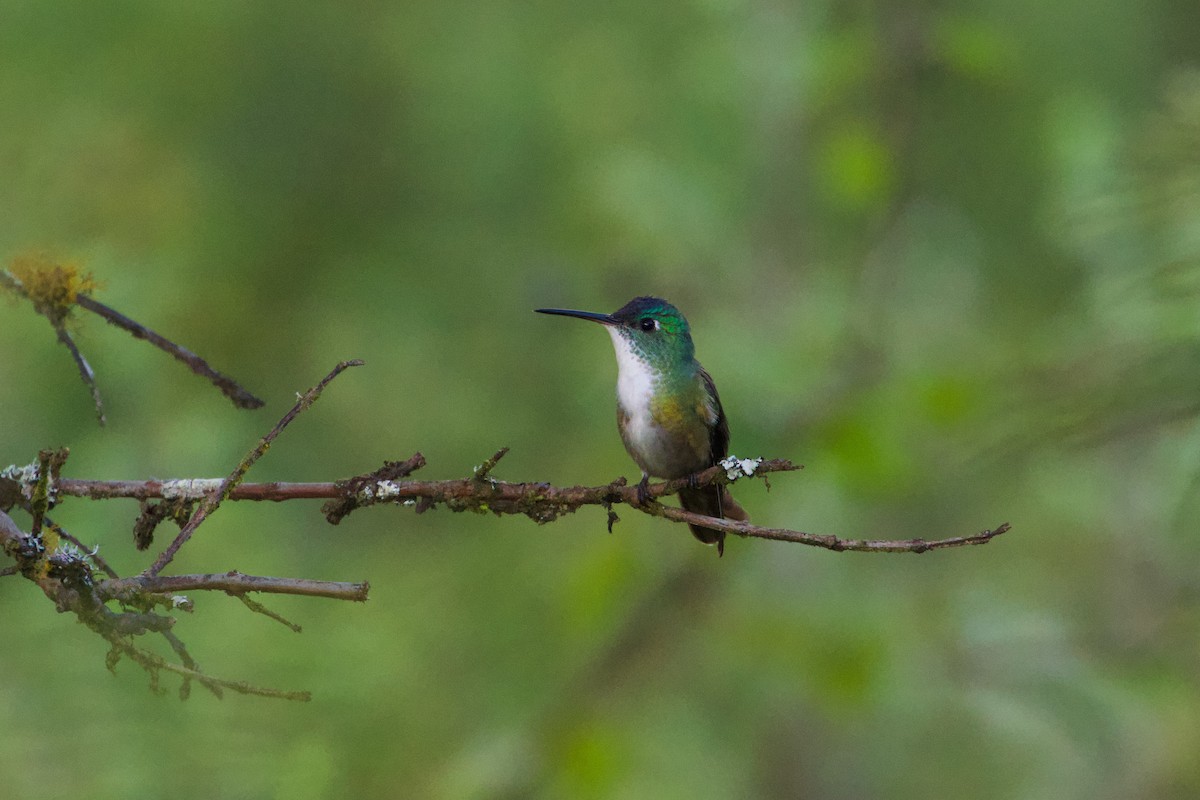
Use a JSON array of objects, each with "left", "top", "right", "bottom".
[{"left": 535, "top": 297, "right": 748, "bottom": 555}]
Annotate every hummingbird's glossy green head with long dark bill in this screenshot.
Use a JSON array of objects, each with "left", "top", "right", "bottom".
[{"left": 538, "top": 297, "right": 695, "bottom": 369}]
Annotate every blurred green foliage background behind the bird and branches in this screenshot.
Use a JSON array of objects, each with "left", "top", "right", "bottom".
[{"left": 0, "top": 0, "right": 1200, "bottom": 800}]
